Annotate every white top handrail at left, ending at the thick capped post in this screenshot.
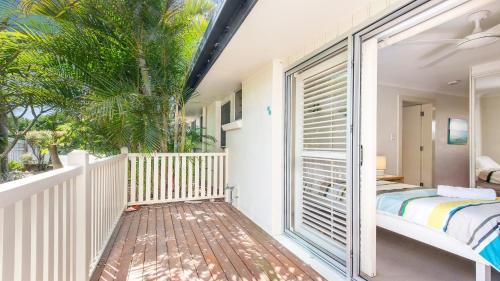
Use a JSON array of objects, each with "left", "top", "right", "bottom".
[{"left": 0, "top": 166, "right": 82, "bottom": 208}]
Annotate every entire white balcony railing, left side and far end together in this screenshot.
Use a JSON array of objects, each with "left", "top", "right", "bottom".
[{"left": 0, "top": 150, "right": 228, "bottom": 281}]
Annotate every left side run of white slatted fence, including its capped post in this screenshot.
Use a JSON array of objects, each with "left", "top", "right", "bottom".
[{"left": 0, "top": 151, "right": 127, "bottom": 281}]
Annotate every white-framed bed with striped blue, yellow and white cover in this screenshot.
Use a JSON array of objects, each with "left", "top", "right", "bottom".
[{"left": 377, "top": 182, "right": 500, "bottom": 281}]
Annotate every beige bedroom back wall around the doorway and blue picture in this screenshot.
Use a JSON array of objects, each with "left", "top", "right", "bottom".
[{"left": 377, "top": 85, "right": 469, "bottom": 186}]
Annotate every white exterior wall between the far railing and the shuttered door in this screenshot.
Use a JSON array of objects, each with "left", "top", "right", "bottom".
[{"left": 226, "top": 61, "right": 283, "bottom": 235}]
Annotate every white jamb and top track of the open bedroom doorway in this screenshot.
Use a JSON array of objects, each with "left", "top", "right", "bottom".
[{"left": 349, "top": 0, "right": 486, "bottom": 280}]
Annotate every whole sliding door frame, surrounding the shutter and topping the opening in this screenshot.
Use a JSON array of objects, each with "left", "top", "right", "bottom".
[{"left": 283, "top": 0, "right": 491, "bottom": 280}]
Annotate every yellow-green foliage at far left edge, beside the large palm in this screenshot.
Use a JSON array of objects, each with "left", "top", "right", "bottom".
[{"left": 0, "top": 2, "right": 81, "bottom": 177}]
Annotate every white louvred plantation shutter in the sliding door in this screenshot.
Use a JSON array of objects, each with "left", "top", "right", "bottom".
[{"left": 294, "top": 49, "right": 348, "bottom": 260}]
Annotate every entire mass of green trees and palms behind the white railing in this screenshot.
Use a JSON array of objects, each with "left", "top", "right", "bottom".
[{"left": 0, "top": 0, "right": 213, "bottom": 179}]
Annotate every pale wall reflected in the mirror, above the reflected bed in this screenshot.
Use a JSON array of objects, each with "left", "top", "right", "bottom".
[{"left": 476, "top": 96, "right": 500, "bottom": 163}]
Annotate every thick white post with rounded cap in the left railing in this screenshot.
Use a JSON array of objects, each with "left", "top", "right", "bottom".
[{"left": 68, "top": 150, "right": 91, "bottom": 281}]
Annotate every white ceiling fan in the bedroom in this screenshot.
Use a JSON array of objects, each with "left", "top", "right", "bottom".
[{"left": 403, "top": 10, "right": 500, "bottom": 68}]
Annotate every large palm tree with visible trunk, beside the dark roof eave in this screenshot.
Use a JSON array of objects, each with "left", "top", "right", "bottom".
[{"left": 20, "top": 0, "right": 212, "bottom": 152}]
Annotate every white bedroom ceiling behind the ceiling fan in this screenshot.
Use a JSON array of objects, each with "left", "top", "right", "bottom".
[{"left": 379, "top": 1, "right": 500, "bottom": 96}]
